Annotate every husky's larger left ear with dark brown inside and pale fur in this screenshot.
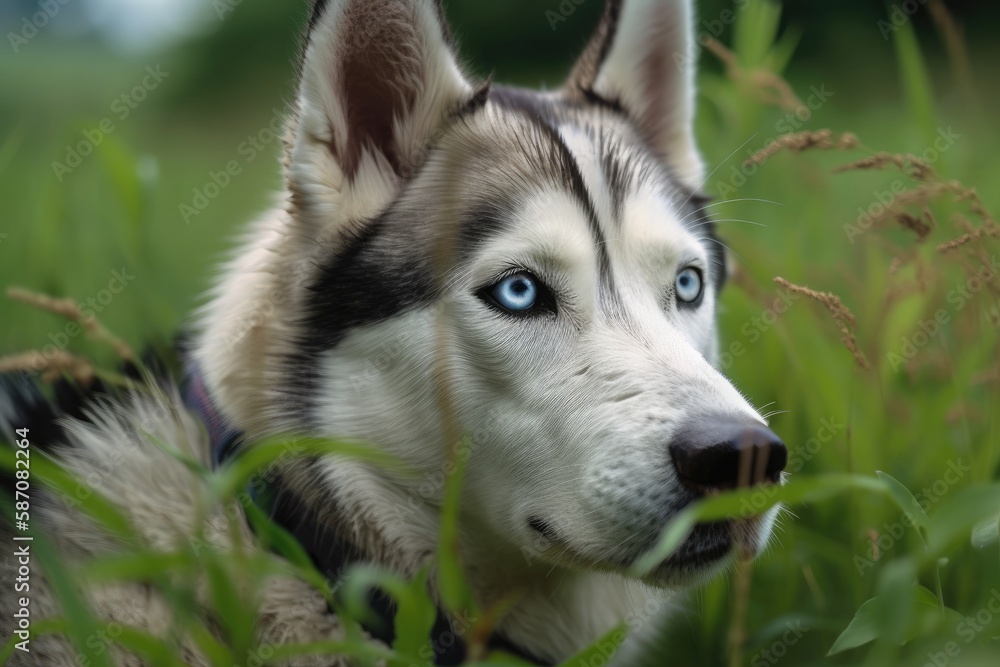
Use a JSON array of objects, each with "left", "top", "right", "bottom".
[{"left": 288, "top": 0, "right": 475, "bottom": 225}]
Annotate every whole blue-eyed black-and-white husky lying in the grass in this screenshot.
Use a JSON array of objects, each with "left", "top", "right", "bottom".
[{"left": 0, "top": 0, "right": 787, "bottom": 666}]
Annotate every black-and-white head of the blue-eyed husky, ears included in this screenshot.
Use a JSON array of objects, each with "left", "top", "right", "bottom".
[{"left": 198, "top": 0, "right": 786, "bottom": 584}]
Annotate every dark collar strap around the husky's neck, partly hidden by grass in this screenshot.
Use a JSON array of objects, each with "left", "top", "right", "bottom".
[{"left": 183, "top": 364, "right": 552, "bottom": 667}]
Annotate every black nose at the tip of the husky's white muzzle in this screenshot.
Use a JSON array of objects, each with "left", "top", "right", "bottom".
[{"left": 670, "top": 416, "right": 788, "bottom": 493}]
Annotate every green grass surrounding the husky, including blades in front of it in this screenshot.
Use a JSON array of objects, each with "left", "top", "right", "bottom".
[{"left": 0, "top": 0, "right": 1000, "bottom": 667}]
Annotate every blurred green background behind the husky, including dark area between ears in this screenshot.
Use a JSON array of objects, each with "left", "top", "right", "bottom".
[{"left": 0, "top": 0, "right": 1000, "bottom": 667}]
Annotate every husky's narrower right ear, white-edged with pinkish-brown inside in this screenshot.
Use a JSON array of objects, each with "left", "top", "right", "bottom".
[{"left": 566, "top": 0, "right": 704, "bottom": 190}]
